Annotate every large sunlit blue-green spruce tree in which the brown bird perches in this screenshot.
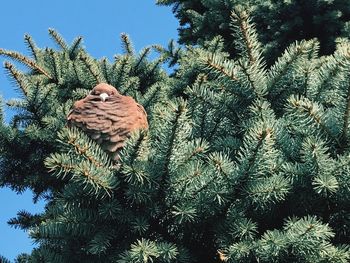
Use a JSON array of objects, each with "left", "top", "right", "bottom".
[{"left": 0, "top": 5, "right": 350, "bottom": 263}]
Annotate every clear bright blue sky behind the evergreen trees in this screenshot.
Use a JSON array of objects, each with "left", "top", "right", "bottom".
[{"left": 0, "top": 0, "right": 178, "bottom": 260}]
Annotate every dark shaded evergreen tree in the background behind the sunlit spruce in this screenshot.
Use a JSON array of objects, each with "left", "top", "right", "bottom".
[{"left": 157, "top": 0, "right": 350, "bottom": 65}]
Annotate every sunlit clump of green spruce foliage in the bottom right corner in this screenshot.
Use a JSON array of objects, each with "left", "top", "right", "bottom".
[{"left": 221, "top": 217, "right": 349, "bottom": 263}]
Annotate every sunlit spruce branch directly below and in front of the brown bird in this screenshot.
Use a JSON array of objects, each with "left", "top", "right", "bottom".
[{"left": 44, "top": 127, "right": 118, "bottom": 196}]
